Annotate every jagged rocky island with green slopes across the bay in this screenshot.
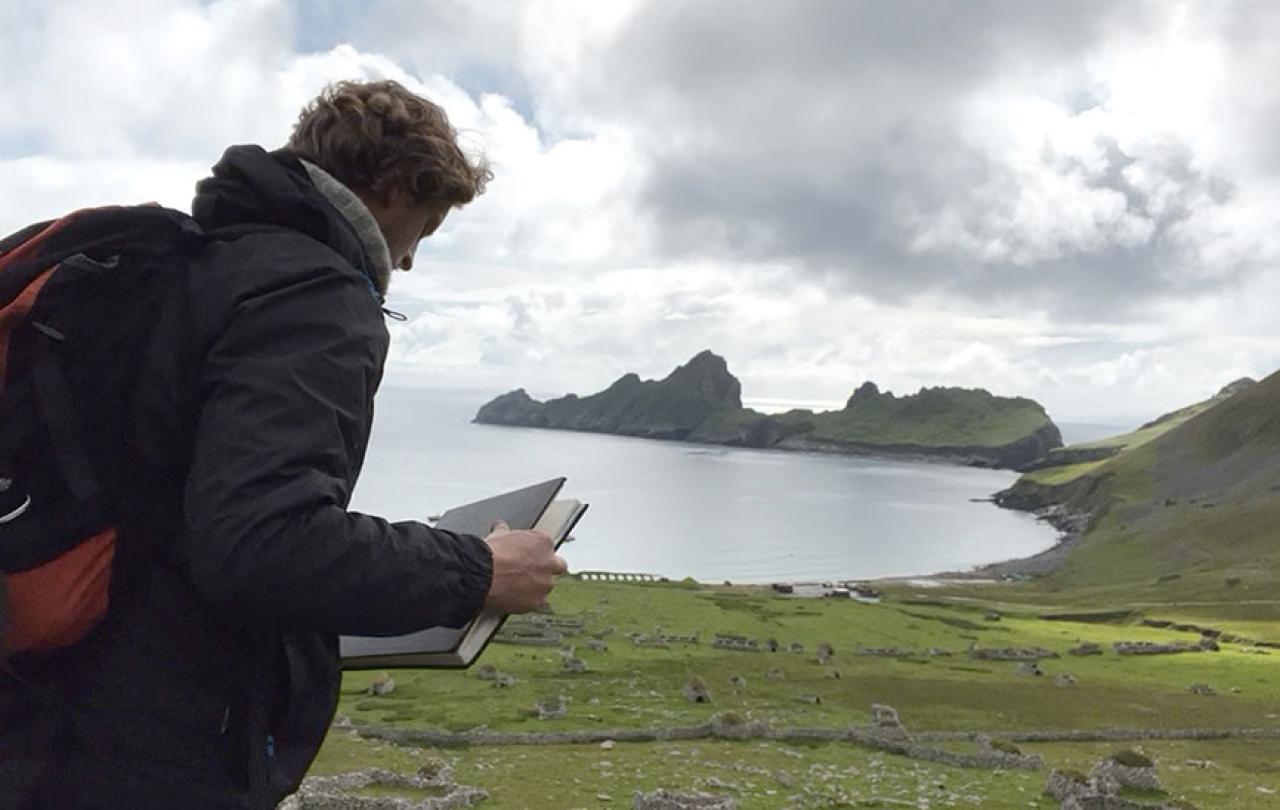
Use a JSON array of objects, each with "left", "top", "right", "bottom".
[{"left": 475, "top": 352, "right": 1062, "bottom": 468}]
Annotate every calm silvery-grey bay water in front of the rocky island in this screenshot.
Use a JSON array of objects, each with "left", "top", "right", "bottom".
[{"left": 352, "top": 386, "right": 1057, "bottom": 582}]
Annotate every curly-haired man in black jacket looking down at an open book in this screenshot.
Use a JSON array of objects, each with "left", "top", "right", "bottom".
[{"left": 0, "top": 82, "right": 564, "bottom": 807}]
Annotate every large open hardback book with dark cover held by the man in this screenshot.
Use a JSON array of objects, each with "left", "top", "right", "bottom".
[{"left": 339, "top": 479, "right": 586, "bottom": 669}]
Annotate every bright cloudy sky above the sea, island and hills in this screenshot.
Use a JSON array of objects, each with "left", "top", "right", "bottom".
[{"left": 0, "top": 0, "right": 1280, "bottom": 425}]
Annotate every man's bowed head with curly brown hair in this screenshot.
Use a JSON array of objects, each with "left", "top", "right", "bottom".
[{"left": 288, "top": 81, "right": 493, "bottom": 270}]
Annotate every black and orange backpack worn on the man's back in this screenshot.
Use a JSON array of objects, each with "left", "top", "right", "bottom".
[{"left": 0, "top": 206, "right": 204, "bottom": 663}]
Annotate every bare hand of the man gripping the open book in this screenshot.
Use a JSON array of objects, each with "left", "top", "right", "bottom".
[{"left": 484, "top": 522, "right": 568, "bottom": 613}]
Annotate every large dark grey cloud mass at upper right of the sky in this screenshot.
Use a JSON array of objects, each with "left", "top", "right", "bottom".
[{"left": 581, "top": 0, "right": 1274, "bottom": 314}]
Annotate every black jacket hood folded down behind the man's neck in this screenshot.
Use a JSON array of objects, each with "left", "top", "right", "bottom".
[{"left": 191, "top": 146, "right": 380, "bottom": 297}]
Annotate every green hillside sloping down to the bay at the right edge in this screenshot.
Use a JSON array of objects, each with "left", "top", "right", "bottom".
[{"left": 1011, "top": 374, "right": 1280, "bottom": 600}]
